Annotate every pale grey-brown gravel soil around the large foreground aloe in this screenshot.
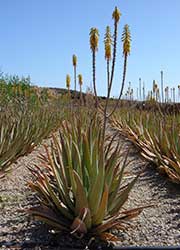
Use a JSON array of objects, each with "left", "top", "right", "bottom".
[{"left": 0, "top": 132, "right": 180, "bottom": 250}]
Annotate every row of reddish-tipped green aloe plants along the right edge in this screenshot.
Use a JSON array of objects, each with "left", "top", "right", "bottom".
[{"left": 111, "top": 108, "right": 180, "bottom": 183}]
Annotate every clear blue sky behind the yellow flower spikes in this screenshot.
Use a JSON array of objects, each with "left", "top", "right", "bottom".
[{"left": 0, "top": 0, "right": 180, "bottom": 96}]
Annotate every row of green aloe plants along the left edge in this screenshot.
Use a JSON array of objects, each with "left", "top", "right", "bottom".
[{"left": 0, "top": 108, "right": 63, "bottom": 175}]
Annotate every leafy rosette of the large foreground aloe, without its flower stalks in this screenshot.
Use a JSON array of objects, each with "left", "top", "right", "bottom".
[{"left": 29, "top": 113, "right": 142, "bottom": 237}]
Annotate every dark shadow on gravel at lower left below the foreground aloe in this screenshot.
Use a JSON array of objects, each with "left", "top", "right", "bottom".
[{"left": 0, "top": 220, "right": 113, "bottom": 250}]
